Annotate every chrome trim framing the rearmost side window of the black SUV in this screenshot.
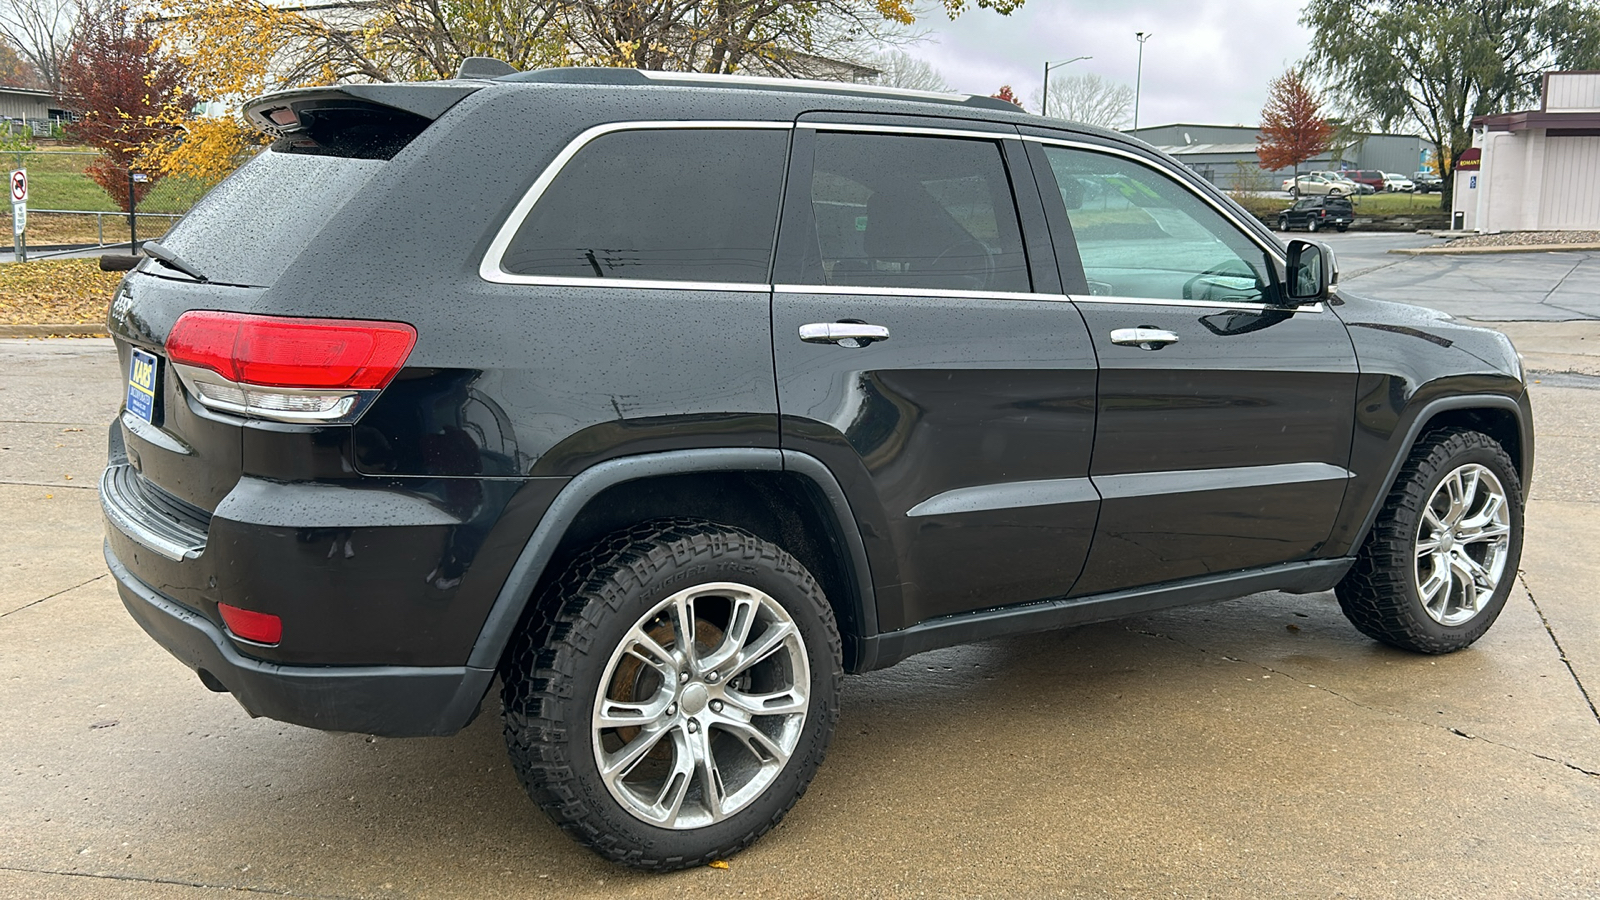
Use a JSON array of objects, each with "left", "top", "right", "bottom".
[{"left": 478, "top": 119, "right": 794, "bottom": 285}]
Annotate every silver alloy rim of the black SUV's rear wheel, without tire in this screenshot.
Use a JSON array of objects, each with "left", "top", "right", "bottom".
[{"left": 592, "top": 581, "right": 811, "bottom": 830}]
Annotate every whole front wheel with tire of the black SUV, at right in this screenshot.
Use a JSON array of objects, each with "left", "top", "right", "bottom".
[{"left": 1334, "top": 429, "right": 1522, "bottom": 653}]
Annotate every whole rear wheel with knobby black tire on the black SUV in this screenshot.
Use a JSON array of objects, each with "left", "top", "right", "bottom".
[{"left": 501, "top": 519, "right": 843, "bottom": 871}]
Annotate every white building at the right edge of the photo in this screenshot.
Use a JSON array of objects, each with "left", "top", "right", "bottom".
[{"left": 1453, "top": 72, "right": 1600, "bottom": 232}]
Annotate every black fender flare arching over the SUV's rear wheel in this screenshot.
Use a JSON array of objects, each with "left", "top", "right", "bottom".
[{"left": 467, "top": 447, "right": 878, "bottom": 669}]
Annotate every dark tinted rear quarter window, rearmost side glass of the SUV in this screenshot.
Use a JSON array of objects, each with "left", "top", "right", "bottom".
[{"left": 501, "top": 128, "right": 789, "bottom": 283}]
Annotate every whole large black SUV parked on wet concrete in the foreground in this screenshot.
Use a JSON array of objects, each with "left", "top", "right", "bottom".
[{"left": 101, "top": 69, "right": 1533, "bottom": 868}]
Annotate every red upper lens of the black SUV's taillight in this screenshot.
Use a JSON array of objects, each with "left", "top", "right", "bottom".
[{"left": 166, "top": 309, "right": 416, "bottom": 391}]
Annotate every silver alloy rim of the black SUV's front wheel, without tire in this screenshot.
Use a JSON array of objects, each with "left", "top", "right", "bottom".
[{"left": 1416, "top": 463, "right": 1510, "bottom": 626}]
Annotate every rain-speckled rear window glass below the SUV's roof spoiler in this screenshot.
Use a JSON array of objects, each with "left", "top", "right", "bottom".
[{"left": 162, "top": 141, "right": 387, "bottom": 287}]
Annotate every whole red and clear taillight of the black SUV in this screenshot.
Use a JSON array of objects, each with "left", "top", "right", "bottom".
[{"left": 166, "top": 309, "right": 416, "bottom": 423}]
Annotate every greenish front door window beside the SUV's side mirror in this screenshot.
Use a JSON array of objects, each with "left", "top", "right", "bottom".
[{"left": 1045, "top": 146, "right": 1278, "bottom": 303}]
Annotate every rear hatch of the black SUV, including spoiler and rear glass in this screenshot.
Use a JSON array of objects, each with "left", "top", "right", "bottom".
[{"left": 102, "top": 82, "right": 478, "bottom": 518}]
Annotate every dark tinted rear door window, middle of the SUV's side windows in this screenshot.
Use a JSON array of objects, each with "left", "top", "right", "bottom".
[{"left": 802, "top": 131, "right": 1030, "bottom": 291}]
